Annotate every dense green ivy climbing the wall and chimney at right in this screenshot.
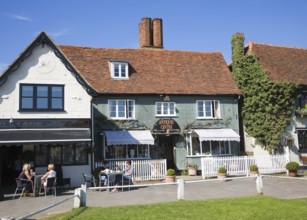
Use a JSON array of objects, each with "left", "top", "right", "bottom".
[{"left": 231, "top": 33, "right": 299, "bottom": 153}]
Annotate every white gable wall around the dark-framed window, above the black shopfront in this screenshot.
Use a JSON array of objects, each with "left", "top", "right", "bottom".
[{"left": 0, "top": 45, "right": 91, "bottom": 119}]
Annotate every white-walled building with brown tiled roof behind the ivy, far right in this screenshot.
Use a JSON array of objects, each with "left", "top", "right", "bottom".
[{"left": 232, "top": 32, "right": 307, "bottom": 164}]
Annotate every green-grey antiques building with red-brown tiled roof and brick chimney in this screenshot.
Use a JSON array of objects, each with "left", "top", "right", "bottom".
[{"left": 59, "top": 18, "right": 241, "bottom": 170}]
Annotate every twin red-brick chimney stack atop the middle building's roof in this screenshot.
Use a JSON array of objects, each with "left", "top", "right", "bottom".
[{"left": 139, "top": 17, "right": 163, "bottom": 49}]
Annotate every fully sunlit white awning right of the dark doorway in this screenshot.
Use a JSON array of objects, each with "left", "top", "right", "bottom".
[{"left": 194, "top": 128, "right": 240, "bottom": 142}]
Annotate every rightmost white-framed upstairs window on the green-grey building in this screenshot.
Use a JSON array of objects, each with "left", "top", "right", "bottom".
[{"left": 196, "top": 100, "right": 221, "bottom": 118}]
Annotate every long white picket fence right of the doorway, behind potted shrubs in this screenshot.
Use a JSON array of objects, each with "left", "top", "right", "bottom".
[{"left": 201, "top": 154, "right": 289, "bottom": 179}]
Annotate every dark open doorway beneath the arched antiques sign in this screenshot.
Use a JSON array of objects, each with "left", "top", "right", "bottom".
[{"left": 158, "top": 135, "right": 175, "bottom": 169}]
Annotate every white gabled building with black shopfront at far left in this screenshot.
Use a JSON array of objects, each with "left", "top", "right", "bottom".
[{"left": 0, "top": 32, "right": 95, "bottom": 186}]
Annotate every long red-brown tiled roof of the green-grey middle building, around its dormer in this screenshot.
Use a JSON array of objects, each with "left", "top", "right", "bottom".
[{"left": 58, "top": 46, "right": 240, "bottom": 95}]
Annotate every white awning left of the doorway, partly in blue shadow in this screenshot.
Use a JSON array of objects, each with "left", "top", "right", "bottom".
[{"left": 104, "top": 130, "right": 154, "bottom": 145}]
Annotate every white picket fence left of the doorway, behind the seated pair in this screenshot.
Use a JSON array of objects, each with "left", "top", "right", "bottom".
[{"left": 95, "top": 159, "right": 166, "bottom": 181}]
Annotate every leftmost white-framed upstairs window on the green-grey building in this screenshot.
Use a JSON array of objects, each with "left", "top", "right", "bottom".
[{"left": 108, "top": 99, "right": 135, "bottom": 119}]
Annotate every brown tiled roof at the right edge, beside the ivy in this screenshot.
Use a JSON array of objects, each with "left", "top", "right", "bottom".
[{"left": 248, "top": 42, "right": 307, "bottom": 85}]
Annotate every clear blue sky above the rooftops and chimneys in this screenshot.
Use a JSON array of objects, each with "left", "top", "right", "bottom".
[{"left": 0, "top": 0, "right": 307, "bottom": 72}]
